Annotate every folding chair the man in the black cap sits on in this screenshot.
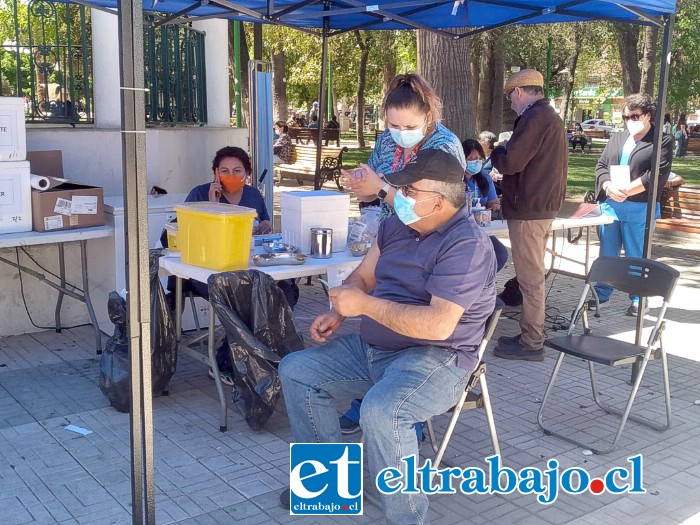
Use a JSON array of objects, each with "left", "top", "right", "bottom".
[{"left": 427, "top": 303, "right": 504, "bottom": 469}]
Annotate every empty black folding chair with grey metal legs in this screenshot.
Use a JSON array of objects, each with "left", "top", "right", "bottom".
[{"left": 537, "top": 257, "right": 680, "bottom": 454}]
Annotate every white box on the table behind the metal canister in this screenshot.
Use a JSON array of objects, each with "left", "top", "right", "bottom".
[{"left": 280, "top": 190, "right": 350, "bottom": 254}]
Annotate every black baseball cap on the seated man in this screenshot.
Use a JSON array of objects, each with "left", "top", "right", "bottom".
[{"left": 384, "top": 148, "right": 464, "bottom": 186}]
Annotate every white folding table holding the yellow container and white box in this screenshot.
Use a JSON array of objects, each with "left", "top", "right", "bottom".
[{"left": 160, "top": 247, "right": 362, "bottom": 432}]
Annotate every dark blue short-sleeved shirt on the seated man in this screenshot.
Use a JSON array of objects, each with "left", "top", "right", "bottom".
[{"left": 360, "top": 206, "right": 496, "bottom": 370}]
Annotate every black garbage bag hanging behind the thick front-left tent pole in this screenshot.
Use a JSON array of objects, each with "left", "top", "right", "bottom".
[{"left": 100, "top": 250, "right": 177, "bottom": 412}]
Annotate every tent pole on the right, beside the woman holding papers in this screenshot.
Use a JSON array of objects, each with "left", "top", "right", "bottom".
[{"left": 632, "top": 15, "right": 675, "bottom": 376}]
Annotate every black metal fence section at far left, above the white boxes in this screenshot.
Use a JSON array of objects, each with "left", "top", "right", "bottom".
[{"left": 0, "top": 0, "right": 93, "bottom": 125}]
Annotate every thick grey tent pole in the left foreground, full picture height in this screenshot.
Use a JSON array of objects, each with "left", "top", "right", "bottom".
[{"left": 119, "top": 0, "right": 156, "bottom": 525}]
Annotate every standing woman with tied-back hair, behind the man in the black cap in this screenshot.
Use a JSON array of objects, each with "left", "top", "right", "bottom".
[{"left": 343, "top": 73, "right": 466, "bottom": 214}]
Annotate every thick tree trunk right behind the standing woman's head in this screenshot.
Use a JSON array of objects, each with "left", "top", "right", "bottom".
[{"left": 417, "top": 28, "right": 475, "bottom": 140}]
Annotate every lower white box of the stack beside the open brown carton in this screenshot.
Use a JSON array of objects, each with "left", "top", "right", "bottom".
[{"left": 0, "top": 160, "right": 32, "bottom": 233}]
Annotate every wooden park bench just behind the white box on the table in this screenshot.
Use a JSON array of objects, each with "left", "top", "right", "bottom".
[{"left": 275, "top": 145, "right": 348, "bottom": 191}]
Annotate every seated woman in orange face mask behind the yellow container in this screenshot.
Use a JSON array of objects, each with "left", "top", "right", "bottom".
[{"left": 185, "top": 146, "right": 272, "bottom": 235}]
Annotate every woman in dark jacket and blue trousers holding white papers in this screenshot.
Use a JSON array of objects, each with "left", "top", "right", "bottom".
[{"left": 588, "top": 93, "right": 673, "bottom": 316}]
